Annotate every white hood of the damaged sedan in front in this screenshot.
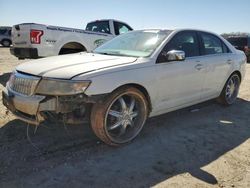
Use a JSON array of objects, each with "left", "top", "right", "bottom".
[{"left": 16, "top": 53, "right": 137, "bottom": 79}]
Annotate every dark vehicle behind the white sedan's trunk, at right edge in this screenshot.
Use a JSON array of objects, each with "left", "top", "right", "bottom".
[{"left": 226, "top": 36, "right": 250, "bottom": 62}]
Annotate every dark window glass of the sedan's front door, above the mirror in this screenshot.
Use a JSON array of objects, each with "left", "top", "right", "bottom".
[{"left": 164, "top": 31, "right": 199, "bottom": 57}]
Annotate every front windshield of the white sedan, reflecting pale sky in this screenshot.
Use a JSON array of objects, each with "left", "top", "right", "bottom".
[{"left": 94, "top": 31, "right": 171, "bottom": 57}]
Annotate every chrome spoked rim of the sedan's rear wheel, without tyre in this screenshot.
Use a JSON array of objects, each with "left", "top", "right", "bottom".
[{"left": 225, "top": 74, "right": 240, "bottom": 104}]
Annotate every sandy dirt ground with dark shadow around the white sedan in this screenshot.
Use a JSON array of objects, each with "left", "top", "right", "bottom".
[{"left": 0, "top": 48, "right": 250, "bottom": 188}]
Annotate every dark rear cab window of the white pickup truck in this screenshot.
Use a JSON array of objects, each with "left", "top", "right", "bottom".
[{"left": 86, "top": 21, "right": 110, "bottom": 34}]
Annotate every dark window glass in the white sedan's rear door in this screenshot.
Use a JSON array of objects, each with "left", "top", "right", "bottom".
[{"left": 201, "top": 33, "right": 223, "bottom": 55}]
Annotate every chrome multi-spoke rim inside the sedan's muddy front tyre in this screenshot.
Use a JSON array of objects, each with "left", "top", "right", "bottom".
[{"left": 105, "top": 93, "right": 147, "bottom": 143}]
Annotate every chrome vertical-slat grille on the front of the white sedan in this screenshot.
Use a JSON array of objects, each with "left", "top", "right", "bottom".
[{"left": 9, "top": 72, "right": 40, "bottom": 95}]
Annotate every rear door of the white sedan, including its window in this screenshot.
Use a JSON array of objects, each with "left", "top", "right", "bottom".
[{"left": 199, "top": 32, "right": 234, "bottom": 99}]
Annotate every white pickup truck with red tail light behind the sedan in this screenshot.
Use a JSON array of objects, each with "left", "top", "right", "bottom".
[{"left": 10, "top": 19, "right": 132, "bottom": 59}]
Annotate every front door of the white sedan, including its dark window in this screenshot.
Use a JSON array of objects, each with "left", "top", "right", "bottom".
[{"left": 156, "top": 31, "right": 206, "bottom": 111}]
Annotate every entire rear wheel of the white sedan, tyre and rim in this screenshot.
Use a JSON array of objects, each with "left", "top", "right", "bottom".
[{"left": 218, "top": 73, "right": 240, "bottom": 106}]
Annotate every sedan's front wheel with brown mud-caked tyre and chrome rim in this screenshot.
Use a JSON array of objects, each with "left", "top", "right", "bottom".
[{"left": 91, "top": 87, "right": 148, "bottom": 145}]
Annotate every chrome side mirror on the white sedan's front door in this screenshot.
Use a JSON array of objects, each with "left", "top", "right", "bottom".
[{"left": 157, "top": 50, "right": 185, "bottom": 63}]
